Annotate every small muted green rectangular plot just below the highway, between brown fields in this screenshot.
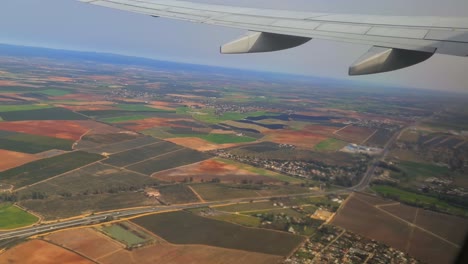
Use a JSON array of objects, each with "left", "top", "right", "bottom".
[{"left": 100, "top": 223, "right": 150, "bottom": 247}]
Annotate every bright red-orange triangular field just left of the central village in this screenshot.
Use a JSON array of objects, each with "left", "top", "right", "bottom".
[{"left": 152, "top": 159, "right": 279, "bottom": 183}]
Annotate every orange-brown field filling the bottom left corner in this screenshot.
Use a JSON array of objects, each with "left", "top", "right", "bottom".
[{"left": 0, "top": 240, "right": 93, "bottom": 264}]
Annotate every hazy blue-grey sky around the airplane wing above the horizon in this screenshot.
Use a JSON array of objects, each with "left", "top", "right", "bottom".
[{"left": 0, "top": 0, "right": 468, "bottom": 93}]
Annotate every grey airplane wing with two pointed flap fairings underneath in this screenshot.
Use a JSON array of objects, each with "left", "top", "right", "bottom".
[{"left": 80, "top": 0, "right": 468, "bottom": 75}]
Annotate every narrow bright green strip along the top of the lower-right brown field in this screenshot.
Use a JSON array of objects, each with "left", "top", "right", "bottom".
[{"left": 371, "top": 185, "right": 468, "bottom": 216}]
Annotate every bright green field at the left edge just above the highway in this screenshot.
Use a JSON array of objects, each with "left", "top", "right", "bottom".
[{"left": 0, "top": 203, "right": 39, "bottom": 230}]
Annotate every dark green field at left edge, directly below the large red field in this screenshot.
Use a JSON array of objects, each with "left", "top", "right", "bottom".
[{"left": 0, "top": 132, "right": 73, "bottom": 154}]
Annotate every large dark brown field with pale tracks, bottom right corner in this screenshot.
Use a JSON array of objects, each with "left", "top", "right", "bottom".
[{"left": 332, "top": 193, "right": 468, "bottom": 264}]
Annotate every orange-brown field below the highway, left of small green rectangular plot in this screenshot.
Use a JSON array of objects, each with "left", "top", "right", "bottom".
[{"left": 46, "top": 228, "right": 123, "bottom": 259}]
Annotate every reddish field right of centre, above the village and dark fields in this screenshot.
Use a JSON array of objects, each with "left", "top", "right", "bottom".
[{"left": 264, "top": 129, "right": 327, "bottom": 148}]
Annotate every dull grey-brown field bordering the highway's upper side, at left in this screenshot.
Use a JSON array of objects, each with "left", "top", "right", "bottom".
[{"left": 19, "top": 191, "right": 159, "bottom": 220}]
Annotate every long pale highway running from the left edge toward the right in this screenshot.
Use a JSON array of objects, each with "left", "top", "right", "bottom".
[{"left": 0, "top": 189, "right": 350, "bottom": 241}]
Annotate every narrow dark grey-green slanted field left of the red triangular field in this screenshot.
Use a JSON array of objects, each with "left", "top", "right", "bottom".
[{"left": 104, "top": 142, "right": 182, "bottom": 167}]
